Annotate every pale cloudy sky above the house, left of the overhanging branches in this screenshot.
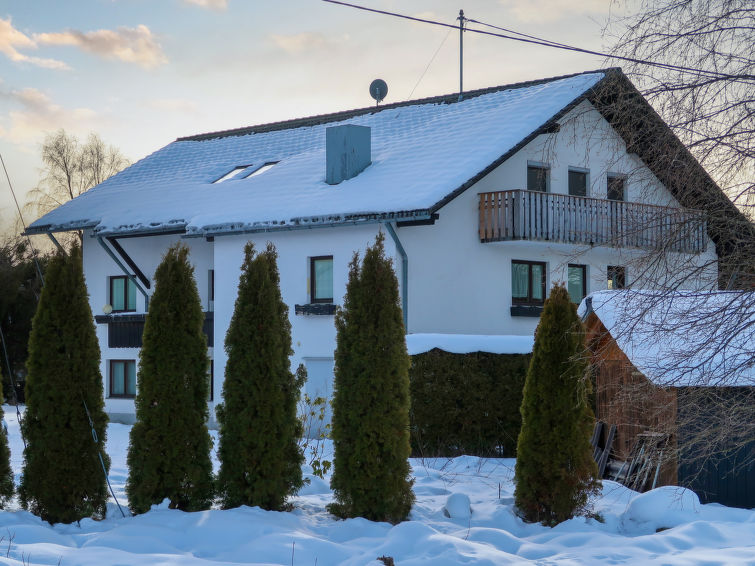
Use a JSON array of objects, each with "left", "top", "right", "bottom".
[{"left": 0, "top": 0, "right": 615, "bottom": 234}]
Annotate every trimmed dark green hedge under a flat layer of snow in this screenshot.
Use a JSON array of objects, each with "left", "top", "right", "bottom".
[{"left": 409, "top": 349, "right": 531, "bottom": 458}]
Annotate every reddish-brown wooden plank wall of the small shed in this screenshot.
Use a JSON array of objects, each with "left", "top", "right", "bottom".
[{"left": 586, "top": 313, "right": 677, "bottom": 485}]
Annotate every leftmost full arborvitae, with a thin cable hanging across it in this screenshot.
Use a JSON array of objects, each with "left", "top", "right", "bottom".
[{"left": 19, "top": 247, "right": 110, "bottom": 523}]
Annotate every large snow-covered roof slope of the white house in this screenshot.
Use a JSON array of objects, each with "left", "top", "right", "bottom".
[{"left": 29, "top": 71, "right": 610, "bottom": 235}]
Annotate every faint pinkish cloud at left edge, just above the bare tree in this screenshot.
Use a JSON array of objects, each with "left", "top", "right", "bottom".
[{"left": 0, "top": 88, "right": 99, "bottom": 144}]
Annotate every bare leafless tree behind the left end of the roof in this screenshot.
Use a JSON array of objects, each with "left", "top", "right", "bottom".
[{"left": 25, "top": 129, "right": 130, "bottom": 244}]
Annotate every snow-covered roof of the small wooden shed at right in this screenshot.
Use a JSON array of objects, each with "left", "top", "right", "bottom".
[{"left": 579, "top": 289, "right": 755, "bottom": 386}]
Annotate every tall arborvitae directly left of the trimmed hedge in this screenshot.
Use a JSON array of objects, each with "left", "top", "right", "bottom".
[{"left": 330, "top": 233, "right": 414, "bottom": 523}]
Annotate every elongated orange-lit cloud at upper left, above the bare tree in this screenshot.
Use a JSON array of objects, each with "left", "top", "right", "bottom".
[{"left": 34, "top": 24, "right": 168, "bottom": 69}]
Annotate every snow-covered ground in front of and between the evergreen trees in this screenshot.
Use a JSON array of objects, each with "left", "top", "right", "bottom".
[{"left": 0, "top": 406, "right": 755, "bottom": 566}]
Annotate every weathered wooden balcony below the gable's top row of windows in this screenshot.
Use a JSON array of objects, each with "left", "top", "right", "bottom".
[{"left": 480, "top": 190, "right": 707, "bottom": 253}]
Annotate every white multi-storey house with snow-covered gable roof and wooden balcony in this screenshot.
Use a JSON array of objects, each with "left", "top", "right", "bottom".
[{"left": 28, "top": 69, "right": 720, "bottom": 426}]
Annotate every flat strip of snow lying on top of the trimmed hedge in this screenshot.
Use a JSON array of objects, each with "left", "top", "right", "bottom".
[{"left": 406, "top": 334, "right": 535, "bottom": 356}]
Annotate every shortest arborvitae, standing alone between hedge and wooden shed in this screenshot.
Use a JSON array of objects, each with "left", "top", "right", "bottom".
[{"left": 514, "top": 284, "right": 600, "bottom": 526}]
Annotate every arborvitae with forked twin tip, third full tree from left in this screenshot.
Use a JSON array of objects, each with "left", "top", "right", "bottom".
[{"left": 217, "top": 242, "right": 304, "bottom": 510}]
